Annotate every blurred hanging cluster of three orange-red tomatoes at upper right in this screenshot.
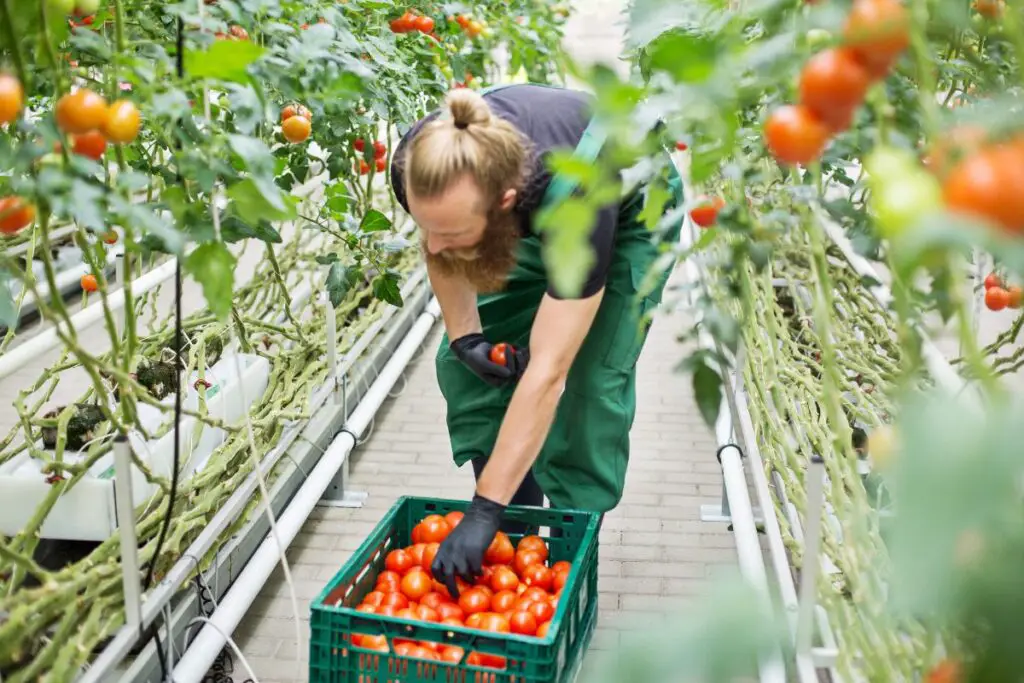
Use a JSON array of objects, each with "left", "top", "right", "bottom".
[{"left": 764, "top": 0, "right": 910, "bottom": 165}]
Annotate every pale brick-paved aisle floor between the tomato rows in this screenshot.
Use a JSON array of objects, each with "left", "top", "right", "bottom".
[{"left": 233, "top": 6, "right": 735, "bottom": 683}]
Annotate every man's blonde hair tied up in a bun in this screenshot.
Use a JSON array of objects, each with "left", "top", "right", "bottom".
[{"left": 404, "top": 88, "right": 529, "bottom": 210}]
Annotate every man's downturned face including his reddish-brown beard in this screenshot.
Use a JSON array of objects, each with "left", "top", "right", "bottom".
[{"left": 409, "top": 175, "right": 519, "bottom": 293}]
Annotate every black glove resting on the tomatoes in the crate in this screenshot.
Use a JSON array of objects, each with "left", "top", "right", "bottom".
[{"left": 430, "top": 495, "right": 505, "bottom": 600}]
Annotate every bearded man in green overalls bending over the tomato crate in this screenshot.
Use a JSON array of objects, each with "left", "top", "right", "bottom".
[{"left": 391, "top": 85, "right": 682, "bottom": 596}]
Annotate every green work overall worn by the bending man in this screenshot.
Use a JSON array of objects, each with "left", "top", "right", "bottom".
[{"left": 436, "top": 86, "right": 683, "bottom": 512}]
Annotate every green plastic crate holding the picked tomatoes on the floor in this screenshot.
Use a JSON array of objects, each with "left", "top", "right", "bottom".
[{"left": 309, "top": 497, "right": 598, "bottom": 683}]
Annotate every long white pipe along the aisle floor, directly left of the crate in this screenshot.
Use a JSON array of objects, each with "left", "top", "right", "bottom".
[{"left": 172, "top": 302, "right": 437, "bottom": 683}]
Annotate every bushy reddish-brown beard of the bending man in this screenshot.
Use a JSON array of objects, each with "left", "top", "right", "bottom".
[{"left": 420, "top": 210, "right": 520, "bottom": 294}]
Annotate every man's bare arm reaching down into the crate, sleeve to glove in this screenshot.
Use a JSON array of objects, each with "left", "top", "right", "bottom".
[{"left": 476, "top": 288, "right": 604, "bottom": 505}]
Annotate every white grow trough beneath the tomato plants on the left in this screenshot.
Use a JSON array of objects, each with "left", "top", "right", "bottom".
[{"left": 0, "top": 353, "right": 270, "bottom": 541}]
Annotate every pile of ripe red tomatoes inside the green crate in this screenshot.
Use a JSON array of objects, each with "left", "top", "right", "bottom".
[{"left": 351, "top": 512, "right": 570, "bottom": 669}]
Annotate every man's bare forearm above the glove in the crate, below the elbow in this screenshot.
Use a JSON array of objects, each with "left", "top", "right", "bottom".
[{"left": 476, "top": 368, "right": 564, "bottom": 505}]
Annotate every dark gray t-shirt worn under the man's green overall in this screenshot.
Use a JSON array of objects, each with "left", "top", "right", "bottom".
[{"left": 391, "top": 85, "right": 618, "bottom": 299}]
